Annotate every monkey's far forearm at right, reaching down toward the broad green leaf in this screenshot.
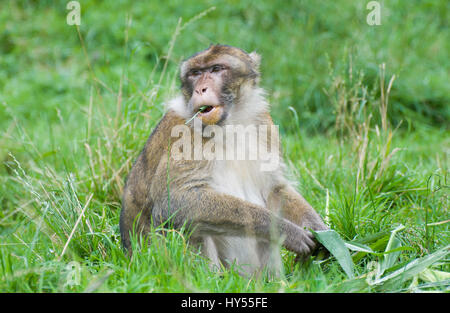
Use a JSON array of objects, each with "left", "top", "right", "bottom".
[{"left": 268, "top": 185, "right": 328, "bottom": 230}]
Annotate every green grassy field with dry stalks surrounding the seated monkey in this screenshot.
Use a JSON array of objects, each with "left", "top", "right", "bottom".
[{"left": 0, "top": 0, "right": 450, "bottom": 292}]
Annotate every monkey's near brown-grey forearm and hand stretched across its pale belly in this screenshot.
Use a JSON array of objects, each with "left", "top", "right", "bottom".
[{"left": 152, "top": 188, "right": 315, "bottom": 255}]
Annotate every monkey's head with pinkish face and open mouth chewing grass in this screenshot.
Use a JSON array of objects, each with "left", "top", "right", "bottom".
[{"left": 180, "top": 45, "right": 260, "bottom": 125}]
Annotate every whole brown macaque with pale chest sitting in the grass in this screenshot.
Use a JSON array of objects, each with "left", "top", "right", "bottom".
[{"left": 120, "top": 45, "right": 327, "bottom": 274}]
